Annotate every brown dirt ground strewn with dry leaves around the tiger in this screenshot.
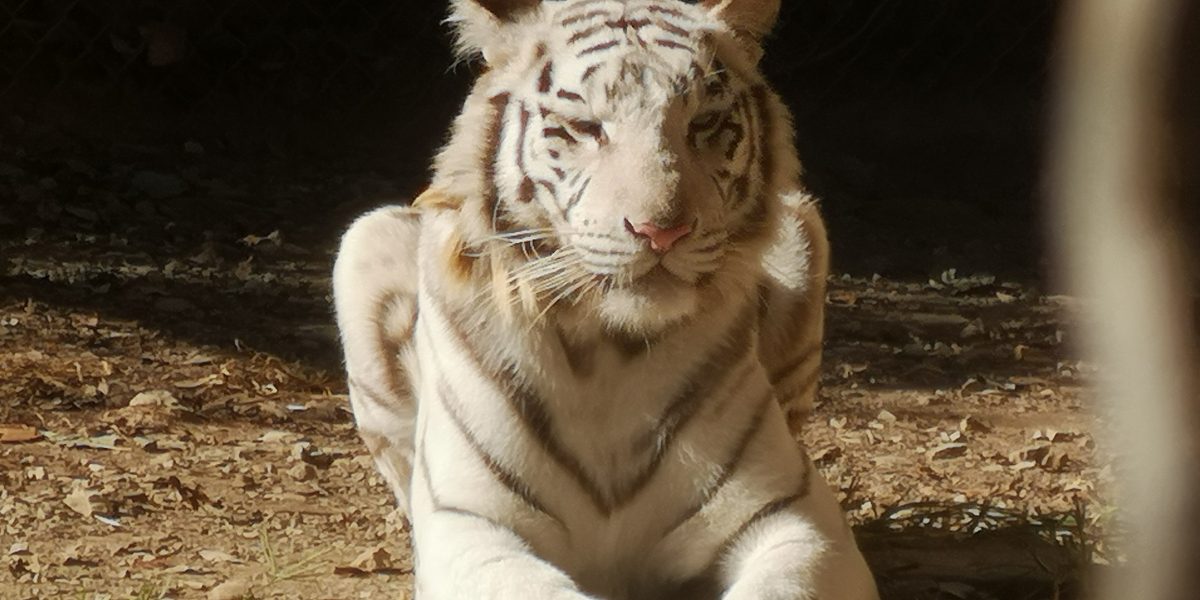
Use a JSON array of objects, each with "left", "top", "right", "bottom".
[{"left": 0, "top": 148, "right": 1104, "bottom": 600}]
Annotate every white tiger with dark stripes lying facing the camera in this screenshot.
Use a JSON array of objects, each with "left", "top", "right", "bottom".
[{"left": 334, "top": 0, "right": 877, "bottom": 600}]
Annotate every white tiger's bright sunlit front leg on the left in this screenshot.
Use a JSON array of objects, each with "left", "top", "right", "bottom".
[{"left": 412, "top": 362, "right": 593, "bottom": 600}]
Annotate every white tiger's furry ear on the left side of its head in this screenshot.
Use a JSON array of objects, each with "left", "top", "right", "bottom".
[{"left": 449, "top": 0, "right": 542, "bottom": 64}]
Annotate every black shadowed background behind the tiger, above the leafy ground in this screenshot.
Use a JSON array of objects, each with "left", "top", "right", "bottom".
[{"left": 0, "top": 0, "right": 1060, "bottom": 280}]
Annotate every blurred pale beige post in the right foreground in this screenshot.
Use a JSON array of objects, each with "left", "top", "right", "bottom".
[{"left": 1052, "top": 0, "right": 1200, "bottom": 600}]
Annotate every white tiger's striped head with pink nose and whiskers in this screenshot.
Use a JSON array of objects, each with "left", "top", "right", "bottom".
[{"left": 434, "top": 0, "right": 799, "bottom": 334}]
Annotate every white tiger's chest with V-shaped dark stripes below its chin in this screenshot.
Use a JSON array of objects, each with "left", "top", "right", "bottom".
[{"left": 416, "top": 289, "right": 791, "bottom": 599}]
